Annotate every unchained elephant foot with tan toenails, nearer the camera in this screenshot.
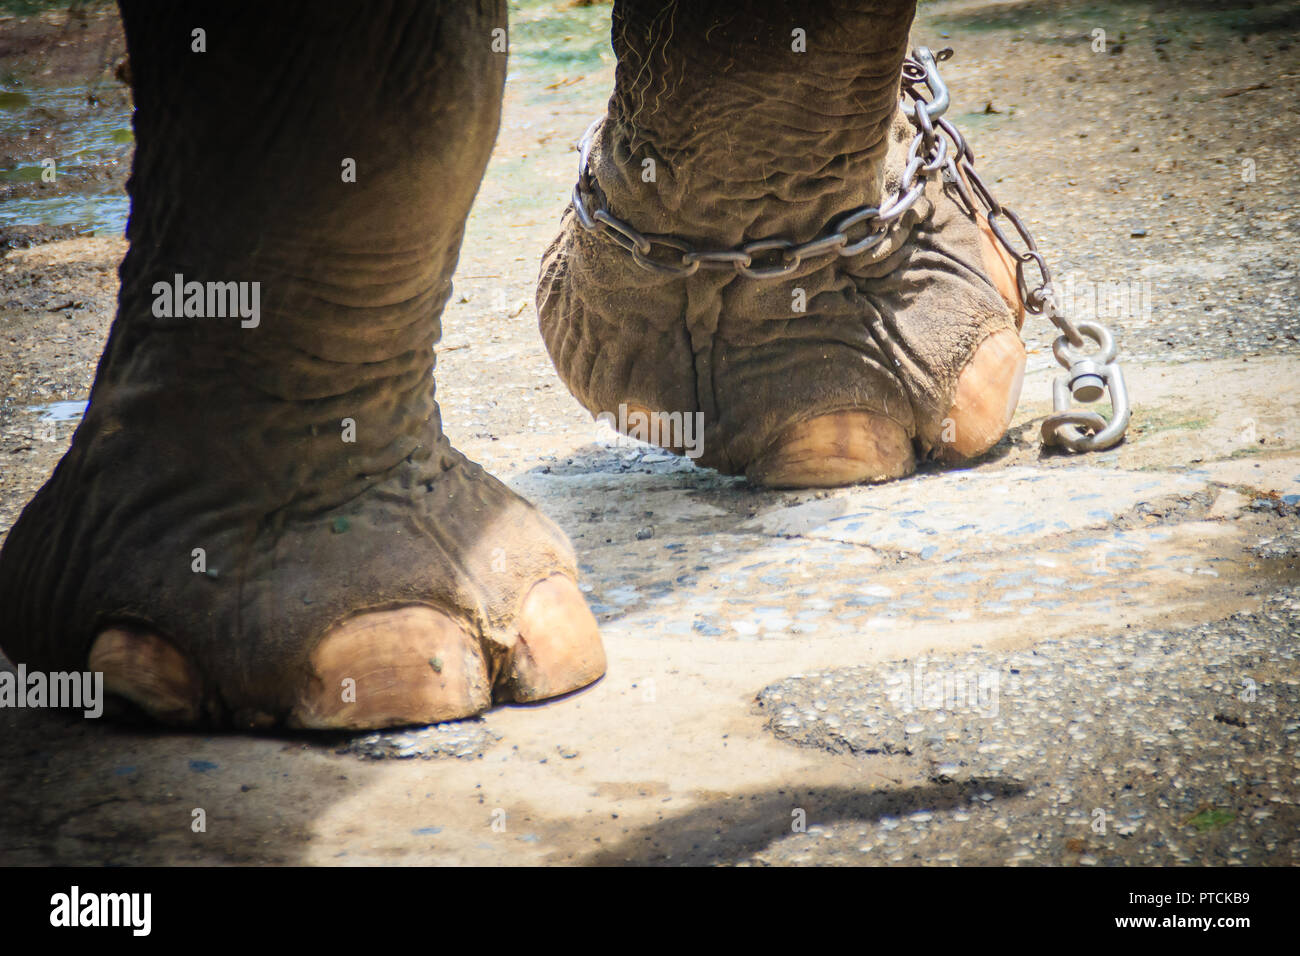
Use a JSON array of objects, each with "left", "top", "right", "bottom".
[{"left": 0, "top": 419, "right": 605, "bottom": 730}]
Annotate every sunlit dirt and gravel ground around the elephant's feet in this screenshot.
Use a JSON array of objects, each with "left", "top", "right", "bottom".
[{"left": 0, "top": 0, "right": 1300, "bottom": 865}]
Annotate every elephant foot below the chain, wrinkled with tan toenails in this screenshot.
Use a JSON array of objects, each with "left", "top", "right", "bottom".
[{"left": 538, "top": 130, "right": 1026, "bottom": 488}]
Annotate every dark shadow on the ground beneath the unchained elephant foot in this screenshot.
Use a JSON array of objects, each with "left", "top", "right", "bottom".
[{"left": 0, "top": 686, "right": 361, "bottom": 866}]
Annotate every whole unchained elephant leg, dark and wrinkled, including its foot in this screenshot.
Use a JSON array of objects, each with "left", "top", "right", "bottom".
[{"left": 0, "top": 0, "right": 605, "bottom": 728}]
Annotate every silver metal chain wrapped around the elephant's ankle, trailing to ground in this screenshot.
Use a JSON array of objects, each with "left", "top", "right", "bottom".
[{"left": 573, "top": 47, "right": 1130, "bottom": 451}]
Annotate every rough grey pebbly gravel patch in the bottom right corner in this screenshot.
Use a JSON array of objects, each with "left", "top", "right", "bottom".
[{"left": 753, "top": 587, "right": 1300, "bottom": 866}]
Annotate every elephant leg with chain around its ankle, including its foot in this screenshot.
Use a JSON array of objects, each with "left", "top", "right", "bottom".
[{"left": 537, "top": 0, "right": 1024, "bottom": 486}]
